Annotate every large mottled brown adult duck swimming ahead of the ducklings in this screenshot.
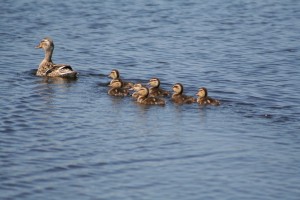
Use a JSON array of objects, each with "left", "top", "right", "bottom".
[{"left": 35, "top": 37, "right": 77, "bottom": 78}]
